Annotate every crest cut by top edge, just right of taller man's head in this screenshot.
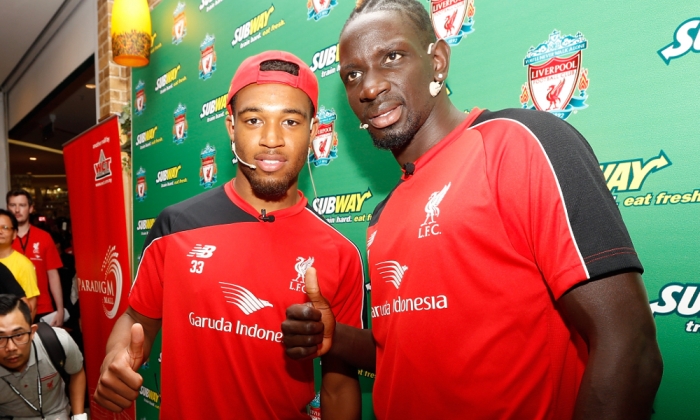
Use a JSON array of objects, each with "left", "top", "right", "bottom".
[{"left": 430, "top": 0, "right": 476, "bottom": 46}]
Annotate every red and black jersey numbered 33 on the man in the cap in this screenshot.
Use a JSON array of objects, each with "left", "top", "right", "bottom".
[{"left": 129, "top": 183, "right": 364, "bottom": 420}]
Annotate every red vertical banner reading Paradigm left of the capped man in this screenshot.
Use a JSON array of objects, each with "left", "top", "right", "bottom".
[{"left": 63, "top": 117, "right": 134, "bottom": 419}]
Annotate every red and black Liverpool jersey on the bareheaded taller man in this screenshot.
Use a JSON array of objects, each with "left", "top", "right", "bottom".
[{"left": 368, "top": 110, "right": 642, "bottom": 420}]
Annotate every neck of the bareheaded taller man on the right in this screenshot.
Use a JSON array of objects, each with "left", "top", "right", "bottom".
[{"left": 393, "top": 99, "right": 466, "bottom": 166}]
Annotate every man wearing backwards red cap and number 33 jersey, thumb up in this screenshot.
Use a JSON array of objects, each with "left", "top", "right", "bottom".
[{"left": 95, "top": 51, "right": 365, "bottom": 420}]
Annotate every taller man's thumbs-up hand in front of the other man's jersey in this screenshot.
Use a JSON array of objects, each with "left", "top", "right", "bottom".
[{"left": 282, "top": 267, "right": 335, "bottom": 360}]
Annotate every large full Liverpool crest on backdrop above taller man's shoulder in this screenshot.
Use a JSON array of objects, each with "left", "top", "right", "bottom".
[{"left": 520, "top": 30, "right": 589, "bottom": 120}]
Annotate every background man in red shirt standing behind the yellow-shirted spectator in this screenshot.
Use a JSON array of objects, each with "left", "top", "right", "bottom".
[{"left": 7, "top": 190, "right": 63, "bottom": 327}]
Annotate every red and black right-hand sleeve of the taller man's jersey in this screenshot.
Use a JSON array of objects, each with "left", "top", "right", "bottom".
[{"left": 480, "top": 110, "right": 643, "bottom": 299}]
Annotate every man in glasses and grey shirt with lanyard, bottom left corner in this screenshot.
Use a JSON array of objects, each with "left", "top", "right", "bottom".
[{"left": 0, "top": 295, "right": 87, "bottom": 420}]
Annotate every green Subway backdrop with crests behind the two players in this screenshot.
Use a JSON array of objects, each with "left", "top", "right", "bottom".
[{"left": 132, "top": 0, "right": 700, "bottom": 420}]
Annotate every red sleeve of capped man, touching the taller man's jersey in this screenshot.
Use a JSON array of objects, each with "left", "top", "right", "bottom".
[{"left": 330, "top": 237, "right": 366, "bottom": 328}]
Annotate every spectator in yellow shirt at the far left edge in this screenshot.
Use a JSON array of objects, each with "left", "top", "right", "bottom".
[{"left": 0, "top": 209, "right": 39, "bottom": 318}]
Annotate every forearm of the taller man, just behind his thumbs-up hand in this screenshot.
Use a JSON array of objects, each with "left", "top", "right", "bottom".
[{"left": 329, "top": 324, "right": 377, "bottom": 372}]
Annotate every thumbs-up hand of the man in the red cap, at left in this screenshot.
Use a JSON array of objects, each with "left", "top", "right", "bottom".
[{"left": 94, "top": 323, "right": 145, "bottom": 413}]
